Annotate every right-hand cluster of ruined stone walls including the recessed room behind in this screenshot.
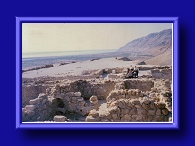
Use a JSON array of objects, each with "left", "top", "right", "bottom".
[{"left": 86, "top": 79, "right": 172, "bottom": 122}]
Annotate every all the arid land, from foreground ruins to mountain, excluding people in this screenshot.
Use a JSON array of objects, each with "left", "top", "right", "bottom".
[{"left": 22, "top": 30, "right": 173, "bottom": 123}]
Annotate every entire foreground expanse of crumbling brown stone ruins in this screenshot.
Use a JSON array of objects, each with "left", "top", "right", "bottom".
[{"left": 22, "top": 68, "right": 172, "bottom": 122}]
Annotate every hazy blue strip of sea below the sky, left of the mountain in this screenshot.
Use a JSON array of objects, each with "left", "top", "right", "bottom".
[{"left": 22, "top": 49, "right": 117, "bottom": 69}]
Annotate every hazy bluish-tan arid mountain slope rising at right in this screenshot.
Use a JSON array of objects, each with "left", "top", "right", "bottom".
[{"left": 118, "top": 29, "right": 172, "bottom": 65}]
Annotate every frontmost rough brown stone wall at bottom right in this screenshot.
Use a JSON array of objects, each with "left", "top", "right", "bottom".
[{"left": 86, "top": 98, "right": 172, "bottom": 122}]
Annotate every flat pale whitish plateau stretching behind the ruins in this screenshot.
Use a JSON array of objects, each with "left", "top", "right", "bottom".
[{"left": 22, "top": 58, "right": 157, "bottom": 78}]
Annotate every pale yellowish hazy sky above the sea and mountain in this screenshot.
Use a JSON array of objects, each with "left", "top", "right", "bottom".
[{"left": 22, "top": 23, "right": 172, "bottom": 53}]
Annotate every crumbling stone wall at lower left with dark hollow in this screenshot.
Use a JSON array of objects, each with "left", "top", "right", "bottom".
[{"left": 22, "top": 90, "right": 91, "bottom": 122}]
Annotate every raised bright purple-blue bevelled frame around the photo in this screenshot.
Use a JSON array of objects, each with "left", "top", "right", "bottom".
[{"left": 16, "top": 17, "right": 179, "bottom": 130}]
